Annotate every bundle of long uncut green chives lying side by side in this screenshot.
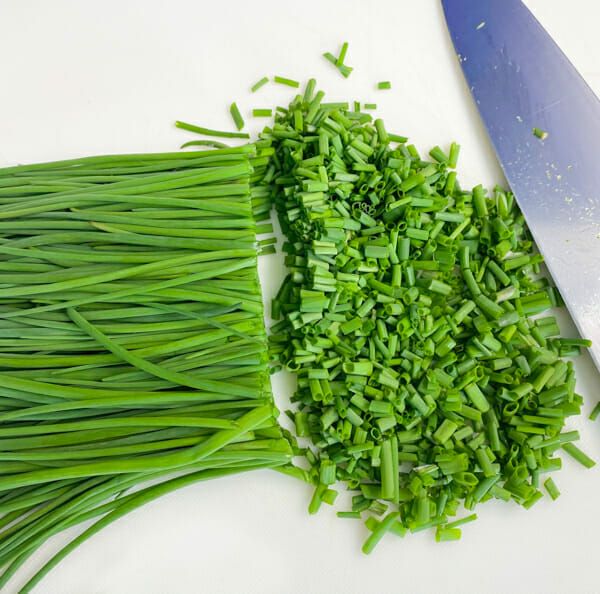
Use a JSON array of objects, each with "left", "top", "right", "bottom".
[{"left": 0, "top": 146, "right": 291, "bottom": 592}]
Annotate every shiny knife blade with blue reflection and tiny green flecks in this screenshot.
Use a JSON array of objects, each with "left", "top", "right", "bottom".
[{"left": 442, "top": 0, "right": 600, "bottom": 369}]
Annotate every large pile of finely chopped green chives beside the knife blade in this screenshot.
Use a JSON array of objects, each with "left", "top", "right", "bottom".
[{"left": 260, "top": 80, "right": 593, "bottom": 553}]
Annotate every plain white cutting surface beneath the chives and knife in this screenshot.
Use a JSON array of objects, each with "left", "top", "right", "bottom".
[{"left": 0, "top": 0, "right": 600, "bottom": 594}]
